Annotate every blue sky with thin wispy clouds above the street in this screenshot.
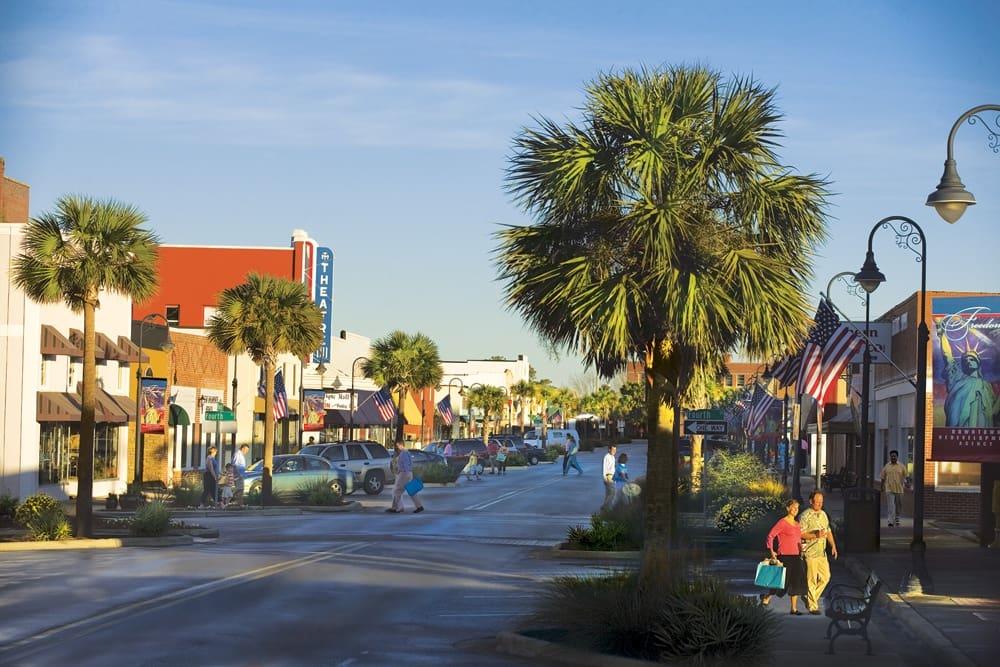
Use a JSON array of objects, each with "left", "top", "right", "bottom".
[{"left": 0, "top": 0, "right": 1000, "bottom": 385}]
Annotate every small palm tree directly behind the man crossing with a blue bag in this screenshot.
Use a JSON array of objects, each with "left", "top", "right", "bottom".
[{"left": 361, "top": 330, "right": 444, "bottom": 441}]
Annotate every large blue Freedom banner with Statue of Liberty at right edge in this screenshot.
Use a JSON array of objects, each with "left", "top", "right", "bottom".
[{"left": 930, "top": 295, "right": 1000, "bottom": 463}]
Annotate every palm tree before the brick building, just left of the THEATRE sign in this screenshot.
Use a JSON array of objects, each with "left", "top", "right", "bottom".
[{"left": 208, "top": 273, "right": 323, "bottom": 505}]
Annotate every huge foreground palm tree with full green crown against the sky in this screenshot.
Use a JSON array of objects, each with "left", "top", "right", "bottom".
[{"left": 496, "top": 67, "right": 827, "bottom": 576}]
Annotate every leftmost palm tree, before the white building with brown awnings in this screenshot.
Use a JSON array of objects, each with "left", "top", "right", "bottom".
[{"left": 12, "top": 195, "right": 159, "bottom": 537}]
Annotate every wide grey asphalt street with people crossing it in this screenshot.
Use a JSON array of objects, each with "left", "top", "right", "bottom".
[{"left": 0, "top": 445, "right": 645, "bottom": 667}]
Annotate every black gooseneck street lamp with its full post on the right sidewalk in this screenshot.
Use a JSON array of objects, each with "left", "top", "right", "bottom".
[{"left": 854, "top": 215, "right": 931, "bottom": 592}]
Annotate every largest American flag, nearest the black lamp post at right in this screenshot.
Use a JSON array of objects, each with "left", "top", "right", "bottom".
[{"left": 797, "top": 299, "right": 864, "bottom": 405}]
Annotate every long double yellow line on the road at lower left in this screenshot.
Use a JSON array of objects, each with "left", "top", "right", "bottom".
[{"left": 0, "top": 542, "right": 370, "bottom": 664}]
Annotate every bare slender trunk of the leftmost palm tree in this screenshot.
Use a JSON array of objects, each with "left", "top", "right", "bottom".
[{"left": 76, "top": 300, "right": 97, "bottom": 537}]
